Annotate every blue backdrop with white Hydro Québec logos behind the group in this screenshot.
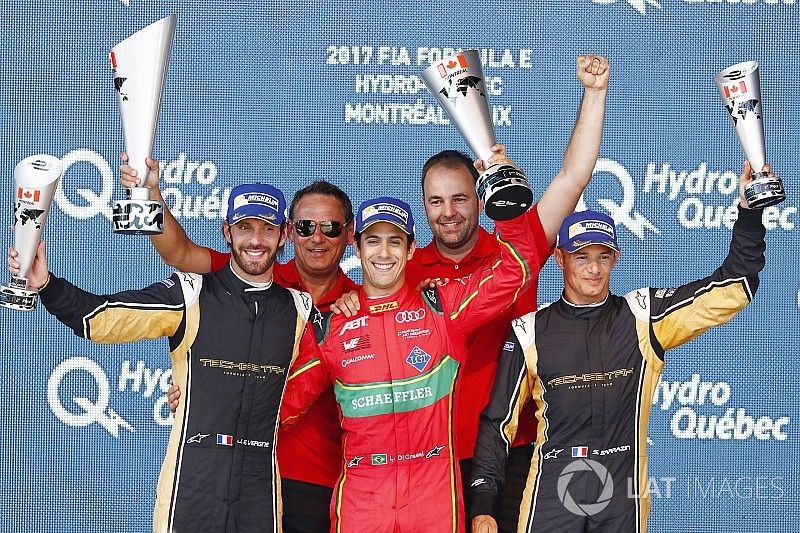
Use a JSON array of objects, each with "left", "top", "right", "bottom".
[{"left": 0, "top": 0, "right": 800, "bottom": 532}]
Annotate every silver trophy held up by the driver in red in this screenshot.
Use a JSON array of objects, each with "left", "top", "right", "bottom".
[{"left": 422, "top": 50, "right": 533, "bottom": 220}]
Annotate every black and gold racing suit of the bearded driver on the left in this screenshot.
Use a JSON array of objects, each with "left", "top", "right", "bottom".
[{"left": 40, "top": 266, "right": 316, "bottom": 533}]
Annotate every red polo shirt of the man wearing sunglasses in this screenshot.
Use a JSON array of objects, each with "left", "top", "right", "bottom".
[{"left": 209, "top": 248, "right": 359, "bottom": 487}]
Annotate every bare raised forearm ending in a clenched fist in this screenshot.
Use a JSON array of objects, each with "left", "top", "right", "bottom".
[{"left": 538, "top": 55, "right": 611, "bottom": 247}]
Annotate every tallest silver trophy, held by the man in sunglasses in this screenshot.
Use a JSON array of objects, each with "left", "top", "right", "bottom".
[{"left": 108, "top": 15, "right": 177, "bottom": 235}]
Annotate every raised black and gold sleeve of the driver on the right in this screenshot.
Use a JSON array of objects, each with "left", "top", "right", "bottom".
[{"left": 650, "top": 207, "right": 766, "bottom": 359}]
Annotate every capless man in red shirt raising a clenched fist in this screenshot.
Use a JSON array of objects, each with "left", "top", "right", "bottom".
[{"left": 406, "top": 56, "right": 610, "bottom": 531}]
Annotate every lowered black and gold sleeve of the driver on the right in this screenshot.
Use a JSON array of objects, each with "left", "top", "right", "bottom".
[{"left": 469, "top": 331, "right": 531, "bottom": 520}]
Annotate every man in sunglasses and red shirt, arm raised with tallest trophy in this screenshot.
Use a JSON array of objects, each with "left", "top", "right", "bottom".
[{"left": 120, "top": 159, "right": 358, "bottom": 533}]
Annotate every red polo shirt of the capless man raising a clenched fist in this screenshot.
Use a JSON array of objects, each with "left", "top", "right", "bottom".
[{"left": 406, "top": 206, "right": 552, "bottom": 459}]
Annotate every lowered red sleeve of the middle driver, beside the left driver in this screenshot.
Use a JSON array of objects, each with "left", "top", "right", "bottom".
[{"left": 280, "top": 324, "right": 331, "bottom": 425}]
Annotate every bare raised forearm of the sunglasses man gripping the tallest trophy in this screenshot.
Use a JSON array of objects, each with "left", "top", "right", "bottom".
[{"left": 119, "top": 152, "right": 211, "bottom": 274}]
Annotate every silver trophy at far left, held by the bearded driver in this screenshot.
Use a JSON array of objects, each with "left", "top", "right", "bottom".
[{"left": 0, "top": 154, "right": 63, "bottom": 311}]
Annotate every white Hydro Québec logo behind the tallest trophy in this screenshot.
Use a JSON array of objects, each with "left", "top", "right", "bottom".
[{"left": 55, "top": 148, "right": 225, "bottom": 220}]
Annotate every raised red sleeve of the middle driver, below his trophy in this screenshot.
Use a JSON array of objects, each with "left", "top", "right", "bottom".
[{"left": 442, "top": 208, "right": 541, "bottom": 332}]
